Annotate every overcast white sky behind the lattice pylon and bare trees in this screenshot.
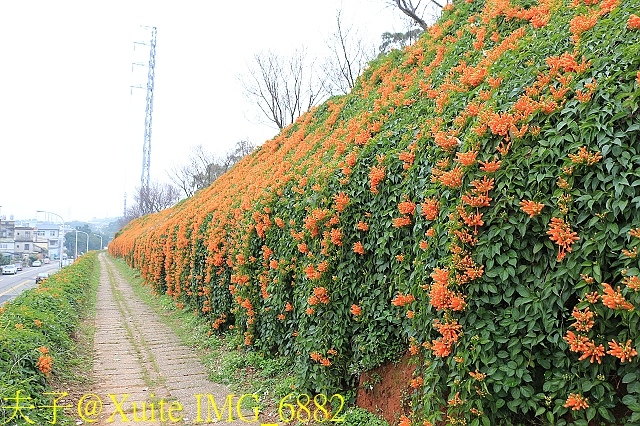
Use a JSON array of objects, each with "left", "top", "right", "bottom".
[{"left": 0, "top": 0, "right": 424, "bottom": 221}]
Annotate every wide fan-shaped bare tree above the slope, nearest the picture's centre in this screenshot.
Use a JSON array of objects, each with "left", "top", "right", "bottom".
[{"left": 240, "top": 48, "right": 326, "bottom": 130}]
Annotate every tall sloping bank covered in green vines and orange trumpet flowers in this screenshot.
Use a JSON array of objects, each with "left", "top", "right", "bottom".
[{"left": 109, "top": 0, "right": 640, "bottom": 425}]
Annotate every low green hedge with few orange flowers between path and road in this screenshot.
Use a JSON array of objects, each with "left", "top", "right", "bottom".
[{"left": 0, "top": 252, "right": 97, "bottom": 425}]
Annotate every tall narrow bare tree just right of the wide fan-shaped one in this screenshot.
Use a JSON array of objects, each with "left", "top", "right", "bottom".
[{"left": 323, "top": 10, "right": 375, "bottom": 94}]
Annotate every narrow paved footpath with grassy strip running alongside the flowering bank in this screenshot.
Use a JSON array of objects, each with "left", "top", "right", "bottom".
[{"left": 91, "top": 253, "right": 261, "bottom": 426}]
